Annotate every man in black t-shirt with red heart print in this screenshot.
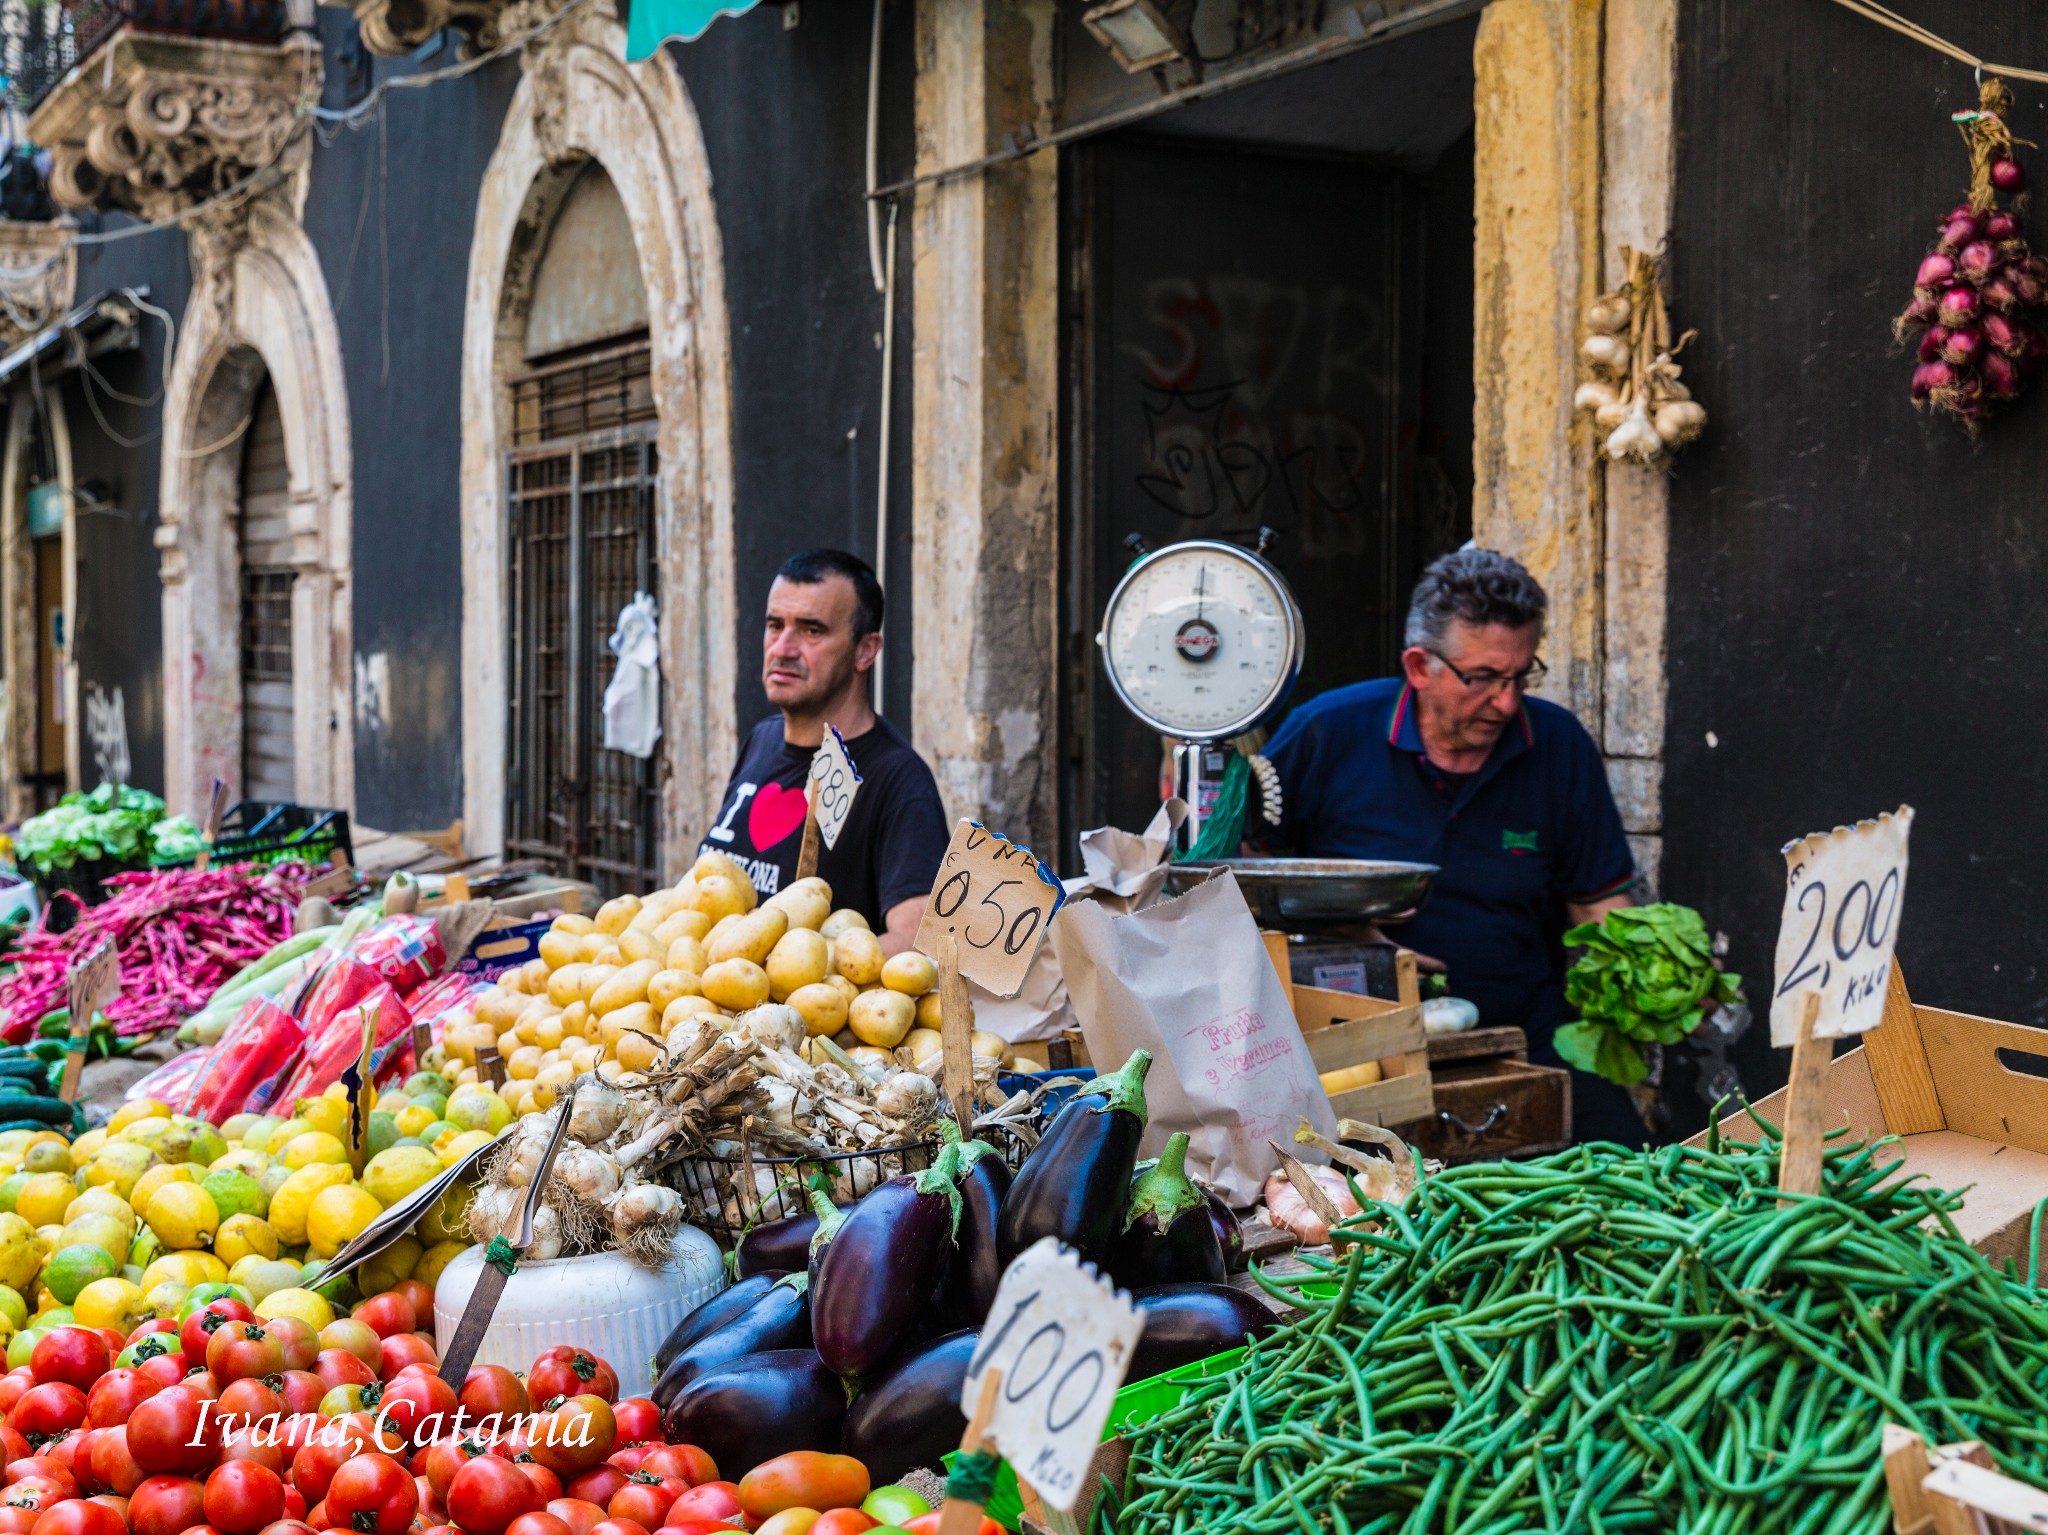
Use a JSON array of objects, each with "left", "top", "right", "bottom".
[{"left": 698, "top": 549, "right": 950, "bottom": 954}]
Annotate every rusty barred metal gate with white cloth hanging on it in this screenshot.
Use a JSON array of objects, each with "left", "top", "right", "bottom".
[{"left": 506, "top": 344, "right": 659, "bottom": 896}]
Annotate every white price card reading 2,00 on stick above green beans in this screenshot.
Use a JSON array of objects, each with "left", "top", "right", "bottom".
[{"left": 1772, "top": 804, "right": 1913, "bottom": 1046}]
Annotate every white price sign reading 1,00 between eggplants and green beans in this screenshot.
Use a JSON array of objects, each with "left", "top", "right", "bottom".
[{"left": 961, "top": 1236, "right": 1145, "bottom": 1510}]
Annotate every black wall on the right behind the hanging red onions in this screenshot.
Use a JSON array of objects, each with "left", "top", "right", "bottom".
[{"left": 1663, "top": 0, "right": 2048, "bottom": 1087}]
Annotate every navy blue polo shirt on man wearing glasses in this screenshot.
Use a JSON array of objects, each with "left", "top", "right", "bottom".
[{"left": 1266, "top": 677, "right": 1636, "bottom": 1056}]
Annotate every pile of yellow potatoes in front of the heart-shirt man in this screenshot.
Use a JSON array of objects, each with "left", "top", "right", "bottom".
[{"left": 444, "top": 851, "right": 1044, "bottom": 1113}]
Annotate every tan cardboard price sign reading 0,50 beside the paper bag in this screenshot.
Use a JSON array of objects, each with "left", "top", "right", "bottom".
[{"left": 913, "top": 821, "right": 1067, "bottom": 997}]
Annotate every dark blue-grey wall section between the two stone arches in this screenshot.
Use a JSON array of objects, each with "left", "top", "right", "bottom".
[{"left": 305, "top": 6, "right": 518, "bottom": 831}]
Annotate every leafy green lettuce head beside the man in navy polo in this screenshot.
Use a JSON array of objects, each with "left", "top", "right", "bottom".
[{"left": 1554, "top": 903, "right": 1743, "bottom": 1087}]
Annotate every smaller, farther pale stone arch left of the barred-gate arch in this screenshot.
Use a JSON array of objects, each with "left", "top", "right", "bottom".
[{"left": 156, "top": 201, "right": 354, "bottom": 817}]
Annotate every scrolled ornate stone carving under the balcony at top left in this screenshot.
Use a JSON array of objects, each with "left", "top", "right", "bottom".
[{"left": 29, "top": 29, "right": 322, "bottom": 219}]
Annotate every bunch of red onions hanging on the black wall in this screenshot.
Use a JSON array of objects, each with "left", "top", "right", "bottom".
[{"left": 1894, "top": 78, "right": 2048, "bottom": 428}]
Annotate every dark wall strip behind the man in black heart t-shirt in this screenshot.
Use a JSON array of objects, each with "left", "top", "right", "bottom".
[{"left": 670, "top": 0, "right": 915, "bottom": 757}]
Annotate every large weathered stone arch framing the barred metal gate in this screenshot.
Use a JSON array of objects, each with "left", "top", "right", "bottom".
[{"left": 463, "top": 10, "right": 739, "bottom": 868}]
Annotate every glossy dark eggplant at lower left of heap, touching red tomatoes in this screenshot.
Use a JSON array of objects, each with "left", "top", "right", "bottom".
[{"left": 662, "top": 1349, "right": 846, "bottom": 1467}]
